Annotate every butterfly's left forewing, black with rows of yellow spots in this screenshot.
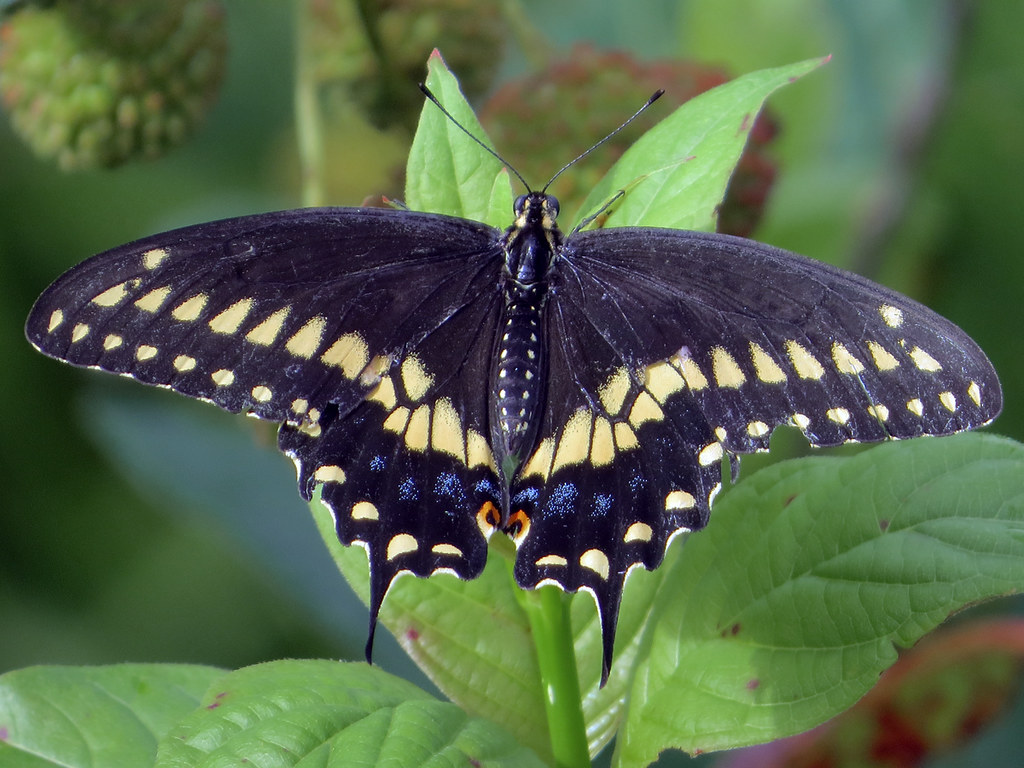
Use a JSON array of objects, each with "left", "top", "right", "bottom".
[{"left": 27, "top": 209, "right": 500, "bottom": 422}]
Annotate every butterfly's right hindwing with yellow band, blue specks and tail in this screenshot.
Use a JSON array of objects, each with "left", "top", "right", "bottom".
[{"left": 510, "top": 294, "right": 724, "bottom": 677}]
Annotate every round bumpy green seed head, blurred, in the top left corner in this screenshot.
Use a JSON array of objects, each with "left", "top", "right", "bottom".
[{"left": 0, "top": 0, "right": 225, "bottom": 170}]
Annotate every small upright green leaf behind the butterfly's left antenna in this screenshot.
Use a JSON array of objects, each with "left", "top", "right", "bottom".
[{"left": 406, "top": 51, "right": 512, "bottom": 222}]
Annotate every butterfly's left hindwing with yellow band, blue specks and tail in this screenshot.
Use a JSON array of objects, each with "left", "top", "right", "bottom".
[{"left": 279, "top": 262, "right": 504, "bottom": 628}]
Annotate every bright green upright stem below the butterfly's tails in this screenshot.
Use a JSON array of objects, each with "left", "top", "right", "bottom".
[{"left": 520, "top": 586, "right": 590, "bottom": 768}]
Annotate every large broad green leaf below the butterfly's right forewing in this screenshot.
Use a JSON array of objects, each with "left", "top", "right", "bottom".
[{"left": 617, "top": 434, "right": 1024, "bottom": 766}]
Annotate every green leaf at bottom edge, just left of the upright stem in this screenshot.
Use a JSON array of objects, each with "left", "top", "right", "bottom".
[{"left": 156, "top": 660, "right": 544, "bottom": 768}]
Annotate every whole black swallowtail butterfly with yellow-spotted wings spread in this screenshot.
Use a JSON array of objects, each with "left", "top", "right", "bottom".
[{"left": 26, "top": 97, "right": 1001, "bottom": 676}]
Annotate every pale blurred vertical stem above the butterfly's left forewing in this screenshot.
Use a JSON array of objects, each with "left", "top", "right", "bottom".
[{"left": 295, "top": 0, "right": 325, "bottom": 207}]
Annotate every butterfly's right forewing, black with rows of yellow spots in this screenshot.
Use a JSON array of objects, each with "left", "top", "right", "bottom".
[{"left": 559, "top": 228, "right": 1001, "bottom": 453}]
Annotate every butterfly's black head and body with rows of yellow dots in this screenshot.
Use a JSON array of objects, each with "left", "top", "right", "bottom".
[{"left": 490, "top": 193, "right": 562, "bottom": 475}]
